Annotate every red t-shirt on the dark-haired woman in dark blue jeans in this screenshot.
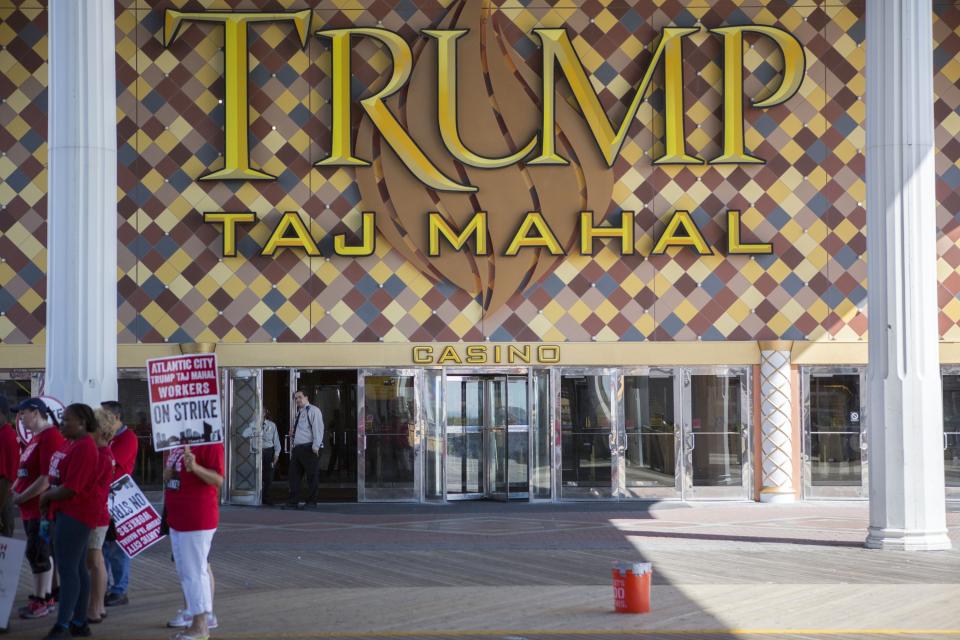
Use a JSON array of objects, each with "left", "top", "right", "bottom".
[{"left": 47, "top": 435, "right": 103, "bottom": 529}]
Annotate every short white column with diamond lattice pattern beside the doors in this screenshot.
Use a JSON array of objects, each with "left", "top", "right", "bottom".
[{"left": 760, "top": 342, "right": 797, "bottom": 502}]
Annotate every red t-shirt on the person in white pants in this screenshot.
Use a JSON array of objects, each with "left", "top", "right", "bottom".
[{"left": 163, "top": 444, "right": 223, "bottom": 531}]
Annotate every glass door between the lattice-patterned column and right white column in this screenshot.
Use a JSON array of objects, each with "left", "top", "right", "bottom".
[{"left": 802, "top": 367, "right": 868, "bottom": 498}]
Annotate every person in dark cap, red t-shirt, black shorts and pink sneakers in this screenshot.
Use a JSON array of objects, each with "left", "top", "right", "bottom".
[{"left": 13, "top": 398, "right": 64, "bottom": 618}]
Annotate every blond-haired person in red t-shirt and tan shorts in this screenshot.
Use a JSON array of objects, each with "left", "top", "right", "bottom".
[{"left": 87, "top": 409, "right": 120, "bottom": 624}]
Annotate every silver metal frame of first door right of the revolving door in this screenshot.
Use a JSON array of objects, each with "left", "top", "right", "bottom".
[{"left": 551, "top": 367, "right": 622, "bottom": 502}]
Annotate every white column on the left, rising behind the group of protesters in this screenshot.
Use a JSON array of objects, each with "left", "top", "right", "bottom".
[{"left": 46, "top": 0, "right": 117, "bottom": 407}]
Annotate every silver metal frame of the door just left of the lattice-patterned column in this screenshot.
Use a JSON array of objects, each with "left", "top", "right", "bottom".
[{"left": 678, "top": 365, "right": 754, "bottom": 502}]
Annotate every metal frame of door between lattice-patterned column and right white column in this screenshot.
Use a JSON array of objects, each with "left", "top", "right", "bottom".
[{"left": 800, "top": 365, "right": 868, "bottom": 500}]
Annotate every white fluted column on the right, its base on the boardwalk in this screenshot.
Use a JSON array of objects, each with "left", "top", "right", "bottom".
[{"left": 866, "top": 0, "right": 950, "bottom": 550}]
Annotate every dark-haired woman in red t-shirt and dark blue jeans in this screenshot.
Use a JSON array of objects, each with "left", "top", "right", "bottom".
[{"left": 40, "top": 404, "right": 103, "bottom": 640}]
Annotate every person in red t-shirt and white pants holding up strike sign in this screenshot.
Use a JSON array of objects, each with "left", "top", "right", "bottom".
[{"left": 163, "top": 443, "right": 224, "bottom": 640}]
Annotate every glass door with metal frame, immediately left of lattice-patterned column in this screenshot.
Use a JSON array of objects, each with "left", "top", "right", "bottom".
[{"left": 681, "top": 367, "right": 752, "bottom": 500}]
